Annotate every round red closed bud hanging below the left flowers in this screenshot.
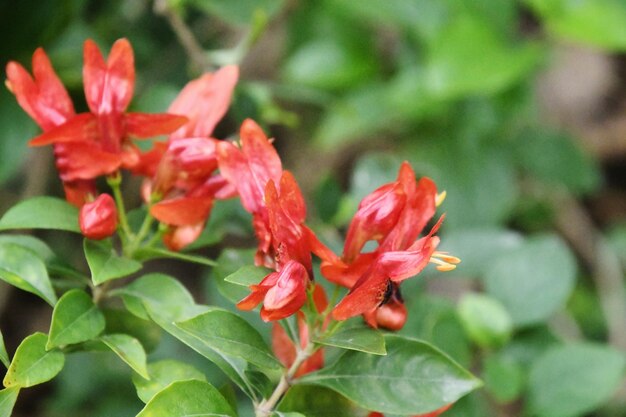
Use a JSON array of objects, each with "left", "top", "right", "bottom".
[{"left": 78, "top": 194, "right": 117, "bottom": 240}]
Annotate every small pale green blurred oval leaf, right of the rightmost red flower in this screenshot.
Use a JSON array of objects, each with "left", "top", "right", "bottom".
[{"left": 458, "top": 293, "right": 513, "bottom": 348}]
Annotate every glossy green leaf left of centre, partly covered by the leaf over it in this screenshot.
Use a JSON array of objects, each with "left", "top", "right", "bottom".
[{"left": 117, "top": 274, "right": 257, "bottom": 398}]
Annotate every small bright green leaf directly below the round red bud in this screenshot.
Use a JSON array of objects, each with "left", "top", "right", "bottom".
[{"left": 83, "top": 239, "right": 142, "bottom": 285}]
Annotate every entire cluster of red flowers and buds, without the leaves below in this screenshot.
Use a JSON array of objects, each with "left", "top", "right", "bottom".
[{"left": 7, "top": 39, "right": 459, "bottom": 416}]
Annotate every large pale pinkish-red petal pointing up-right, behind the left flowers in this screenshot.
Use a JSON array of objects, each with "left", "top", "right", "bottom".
[{"left": 168, "top": 65, "right": 239, "bottom": 140}]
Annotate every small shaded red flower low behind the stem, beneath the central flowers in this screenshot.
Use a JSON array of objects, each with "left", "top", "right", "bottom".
[{"left": 272, "top": 285, "right": 328, "bottom": 377}]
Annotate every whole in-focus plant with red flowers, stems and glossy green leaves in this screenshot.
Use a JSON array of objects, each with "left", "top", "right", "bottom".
[{"left": 0, "top": 39, "right": 480, "bottom": 417}]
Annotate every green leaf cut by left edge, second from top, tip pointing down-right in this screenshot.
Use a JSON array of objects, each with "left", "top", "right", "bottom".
[{"left": 0, "top": 242, "right": 57, "bottom": 306}]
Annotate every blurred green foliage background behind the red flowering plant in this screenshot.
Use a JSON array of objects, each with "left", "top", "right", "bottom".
[{"left": 0, "top": 0, "right": 626, "bottom": 417}]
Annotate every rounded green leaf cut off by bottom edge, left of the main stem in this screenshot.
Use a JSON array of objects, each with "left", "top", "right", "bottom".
[{"left": 137, "top": 380, "right": 236, "bottom": 417}]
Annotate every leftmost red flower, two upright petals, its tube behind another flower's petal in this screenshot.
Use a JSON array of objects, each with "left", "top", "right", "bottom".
[{"left": 6, "top": 48, "right": 96, "bottom": 207}]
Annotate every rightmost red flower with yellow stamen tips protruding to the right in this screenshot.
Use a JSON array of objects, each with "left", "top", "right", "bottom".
[{"left": 313, "top": 162, "right": 459, "bottom": 330}]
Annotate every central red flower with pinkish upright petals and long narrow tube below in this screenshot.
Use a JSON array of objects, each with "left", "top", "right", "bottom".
[{"left": 217, "top": 119, "right": 282, "bottom": 268}]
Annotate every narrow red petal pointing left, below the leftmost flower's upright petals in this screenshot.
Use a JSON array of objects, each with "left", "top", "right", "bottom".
[{"left": 28, "top": 113, "right": 99, "bottom": 146}]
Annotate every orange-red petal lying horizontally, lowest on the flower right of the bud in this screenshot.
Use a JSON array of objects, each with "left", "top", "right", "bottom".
[{"left": 150, "top": 197, "right": 213, "bottom": 226}]
